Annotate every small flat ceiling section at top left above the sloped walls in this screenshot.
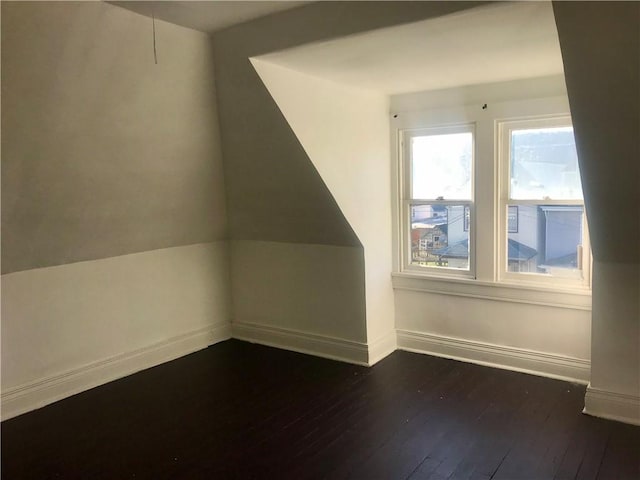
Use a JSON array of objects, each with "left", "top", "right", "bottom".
[{"left": 107, "top": 0, "right": 309, "bottom": 33}]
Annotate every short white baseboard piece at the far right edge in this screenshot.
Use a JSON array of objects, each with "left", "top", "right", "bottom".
[{"left": 582, "top": 384, "right": 640, "bottom": 425}]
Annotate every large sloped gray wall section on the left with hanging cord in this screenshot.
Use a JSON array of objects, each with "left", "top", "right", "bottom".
[{"left": 2, "top": 2, "right": 226, "bottom": 273}]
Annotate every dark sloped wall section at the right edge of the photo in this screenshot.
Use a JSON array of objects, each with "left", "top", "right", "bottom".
[{"left": 553, "top": 2, "right": 640, "bottom": 263}]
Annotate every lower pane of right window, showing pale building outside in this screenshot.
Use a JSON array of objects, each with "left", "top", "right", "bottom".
[{"left": 507, "top": 205, "right": 584, "bottom": 276}]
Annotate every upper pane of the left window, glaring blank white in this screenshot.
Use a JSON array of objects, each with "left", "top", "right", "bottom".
[{"left": 411, "top": 132, "right": 473, "bottom": 200}]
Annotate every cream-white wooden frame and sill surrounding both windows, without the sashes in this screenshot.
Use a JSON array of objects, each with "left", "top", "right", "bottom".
[{"left": 390, "top": 94, "right": 592, "bottom": 304}]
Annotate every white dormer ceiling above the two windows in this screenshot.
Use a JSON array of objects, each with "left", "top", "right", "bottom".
[{"left": 255, "top": 2, "right": 563, "bottom": 95}]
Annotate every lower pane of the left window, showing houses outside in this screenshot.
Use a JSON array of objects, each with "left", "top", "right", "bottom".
[{"left": 411, "top": 204, "right": 470, "bottom": 270}]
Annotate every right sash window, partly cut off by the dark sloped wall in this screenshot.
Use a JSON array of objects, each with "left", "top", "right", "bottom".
[{"left": 498, "top": 117, "right": 588, "bottom": 284}]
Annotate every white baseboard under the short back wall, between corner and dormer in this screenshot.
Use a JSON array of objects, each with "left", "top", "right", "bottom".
[{"left": 231, "top": 322, "right": 369, "bottom": 365}]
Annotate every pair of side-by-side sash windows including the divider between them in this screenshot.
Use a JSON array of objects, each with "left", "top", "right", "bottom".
[{"left": 392, "top": 97, "right": 591, "bottom": 292}]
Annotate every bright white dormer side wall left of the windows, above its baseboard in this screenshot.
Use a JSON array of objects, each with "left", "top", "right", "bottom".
[{"left": 251, "top": 58, "right": 394, "bottom": 343}]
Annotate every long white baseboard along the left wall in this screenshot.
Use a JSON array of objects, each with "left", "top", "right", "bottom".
[{"left": 2, "top": 323, "right": 231, "bottom": 420}]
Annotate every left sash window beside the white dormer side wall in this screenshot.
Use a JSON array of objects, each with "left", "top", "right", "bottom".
[{"left": 402, "top": 125, "right": 474, "bottom": 275}]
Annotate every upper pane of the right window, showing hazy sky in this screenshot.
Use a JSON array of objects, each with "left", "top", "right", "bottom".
[{"left": 510, "top": 127, "right": 582, "bottom": 200}]
